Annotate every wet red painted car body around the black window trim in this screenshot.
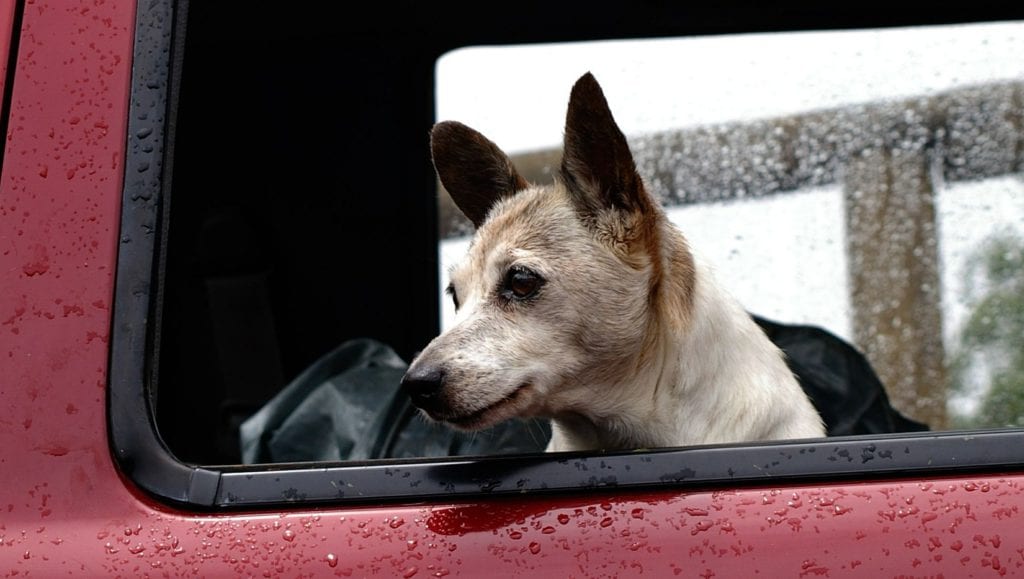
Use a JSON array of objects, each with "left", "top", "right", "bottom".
[{"left": 0, "top": 0, "right": 1024, "bottom": 578}]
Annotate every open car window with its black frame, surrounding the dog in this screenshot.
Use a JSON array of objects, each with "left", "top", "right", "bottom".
[{"left": 111, "top": 2, "right": 1024, "bottom": 507}]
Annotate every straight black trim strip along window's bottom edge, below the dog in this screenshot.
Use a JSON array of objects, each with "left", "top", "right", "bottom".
[{"left": 214, "top": 430, "right": 1024, "bottom": 507}]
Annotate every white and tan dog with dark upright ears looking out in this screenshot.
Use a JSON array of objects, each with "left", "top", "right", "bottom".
[{"left": 401, "top": 73, "right": 825, "bottom": 452}]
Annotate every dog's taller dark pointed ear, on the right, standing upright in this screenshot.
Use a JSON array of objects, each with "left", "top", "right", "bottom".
[{"left": 561, "top": 73, "right": 651, "bottom": 221}]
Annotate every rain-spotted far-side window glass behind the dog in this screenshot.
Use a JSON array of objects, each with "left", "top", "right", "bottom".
[{"left": 436, "top": 23, "right": 1024, "bottom": 429}]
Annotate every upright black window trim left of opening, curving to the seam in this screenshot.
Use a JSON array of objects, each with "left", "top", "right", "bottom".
[{"left": 108, "top": 0, "right": 220, "bottom": 505}]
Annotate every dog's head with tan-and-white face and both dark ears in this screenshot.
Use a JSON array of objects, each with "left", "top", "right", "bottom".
[{"left": 402, "top": 73, "right": 689, "bottom": 429}]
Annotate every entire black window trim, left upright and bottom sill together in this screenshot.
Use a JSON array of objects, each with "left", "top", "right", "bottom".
[{"left": 108, "top": 0, "right": 1024, "bottom": 508}]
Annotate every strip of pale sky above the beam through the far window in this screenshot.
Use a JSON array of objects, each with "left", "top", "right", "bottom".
[{"left": 437, "top": 22, "right": 1024, "bottom": 153}]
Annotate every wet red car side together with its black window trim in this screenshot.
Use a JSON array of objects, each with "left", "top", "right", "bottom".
[{"left": 0, "top": 0, "right": 1024, "bottom": 578}]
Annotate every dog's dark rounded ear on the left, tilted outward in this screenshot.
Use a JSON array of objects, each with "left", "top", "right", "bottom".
[{"left": 430, "top": 121, "right": 529, "bottom": 228}]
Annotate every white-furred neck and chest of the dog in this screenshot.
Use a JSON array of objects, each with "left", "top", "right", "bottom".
[{"left": 548, "top": 243, "right": 820, "bottom": 451}]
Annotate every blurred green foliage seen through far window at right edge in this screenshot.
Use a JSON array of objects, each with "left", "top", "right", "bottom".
[{"left": 950, "top": 232, "right": 1024, "bottom": 428}]
